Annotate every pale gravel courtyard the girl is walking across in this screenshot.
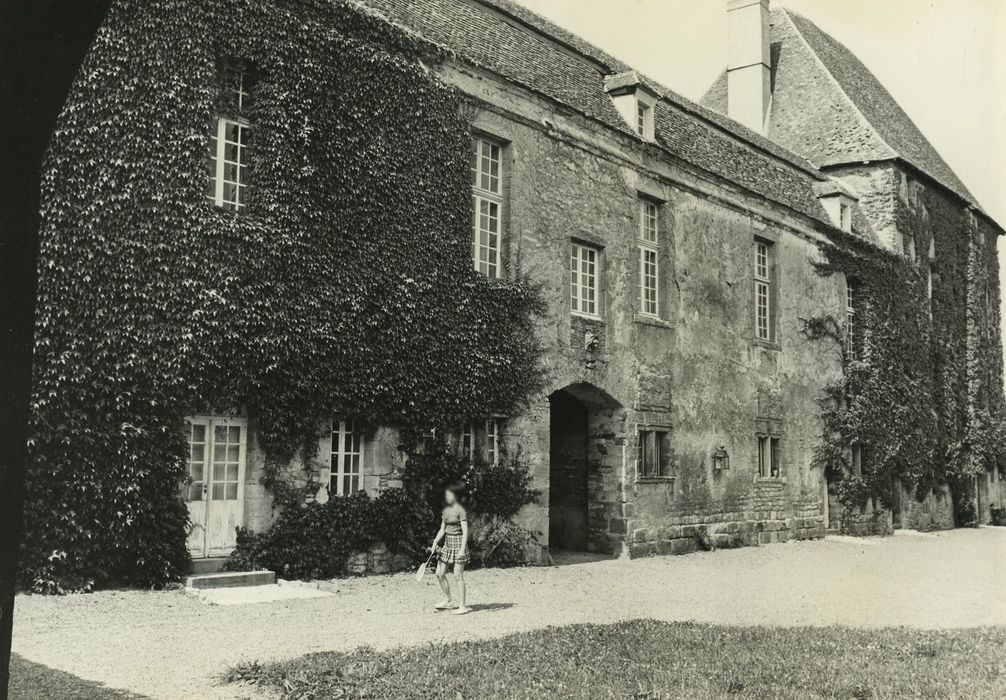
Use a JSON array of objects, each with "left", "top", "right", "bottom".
[{"left": 14, "top": 528, "right": 1006, "bottom": 700}]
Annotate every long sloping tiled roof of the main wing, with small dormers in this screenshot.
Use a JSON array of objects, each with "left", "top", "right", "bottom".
[{"left": 357, "top": 0, "right": 830, "bottom": 223}]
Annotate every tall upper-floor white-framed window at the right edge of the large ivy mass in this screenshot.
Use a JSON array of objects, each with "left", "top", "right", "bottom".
[{"left": 472, "top": 137, "right": 503, "bottom": 278}]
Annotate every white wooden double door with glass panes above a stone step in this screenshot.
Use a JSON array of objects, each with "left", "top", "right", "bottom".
[{"left": 185, "top": 415, "right": 247, "bottom": 558}]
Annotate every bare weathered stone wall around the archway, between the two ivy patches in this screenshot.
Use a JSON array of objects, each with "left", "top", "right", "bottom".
[{"left": 452, "top": 62, "right": 843, "bottom": 554}]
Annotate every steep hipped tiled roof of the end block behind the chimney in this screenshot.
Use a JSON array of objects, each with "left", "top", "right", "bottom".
[{"left": 702, "top": 9, "right": 979, "bottom": 213}]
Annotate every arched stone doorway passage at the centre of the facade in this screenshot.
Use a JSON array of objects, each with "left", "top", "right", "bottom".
[{"left": 548, "top": 383, "right": 626, "bottom": 554}]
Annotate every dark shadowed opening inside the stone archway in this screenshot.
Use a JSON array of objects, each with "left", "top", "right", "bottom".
[{"left": 548, "top": 391, "right": 588, "bottom": 551}]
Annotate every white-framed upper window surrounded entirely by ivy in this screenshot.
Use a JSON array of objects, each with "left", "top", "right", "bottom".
[{"left": 206, "top": 65, "right": 250, "bottom": 211}]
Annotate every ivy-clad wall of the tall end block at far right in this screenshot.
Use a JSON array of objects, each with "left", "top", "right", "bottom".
[{"left": 819, "top": 163, "right": 1006, "bottom": 526}]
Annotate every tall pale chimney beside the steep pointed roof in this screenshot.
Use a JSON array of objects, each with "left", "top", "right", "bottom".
[{"left": 726, "top": 0, "right": 772, "bottom": 134}]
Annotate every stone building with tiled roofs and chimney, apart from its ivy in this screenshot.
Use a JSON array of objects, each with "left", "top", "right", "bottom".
[{"left": 183, "top": 0, "right": 1006, "bottom": 556}]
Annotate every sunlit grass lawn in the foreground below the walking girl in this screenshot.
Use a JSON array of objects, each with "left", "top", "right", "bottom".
[{"left": 227, "top": 620, "right": 1006, "bottom": 700}]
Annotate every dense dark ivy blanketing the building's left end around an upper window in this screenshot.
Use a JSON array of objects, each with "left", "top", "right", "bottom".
[{"left": 23, "top": 0, "right": 540, "bottom": 590}]
